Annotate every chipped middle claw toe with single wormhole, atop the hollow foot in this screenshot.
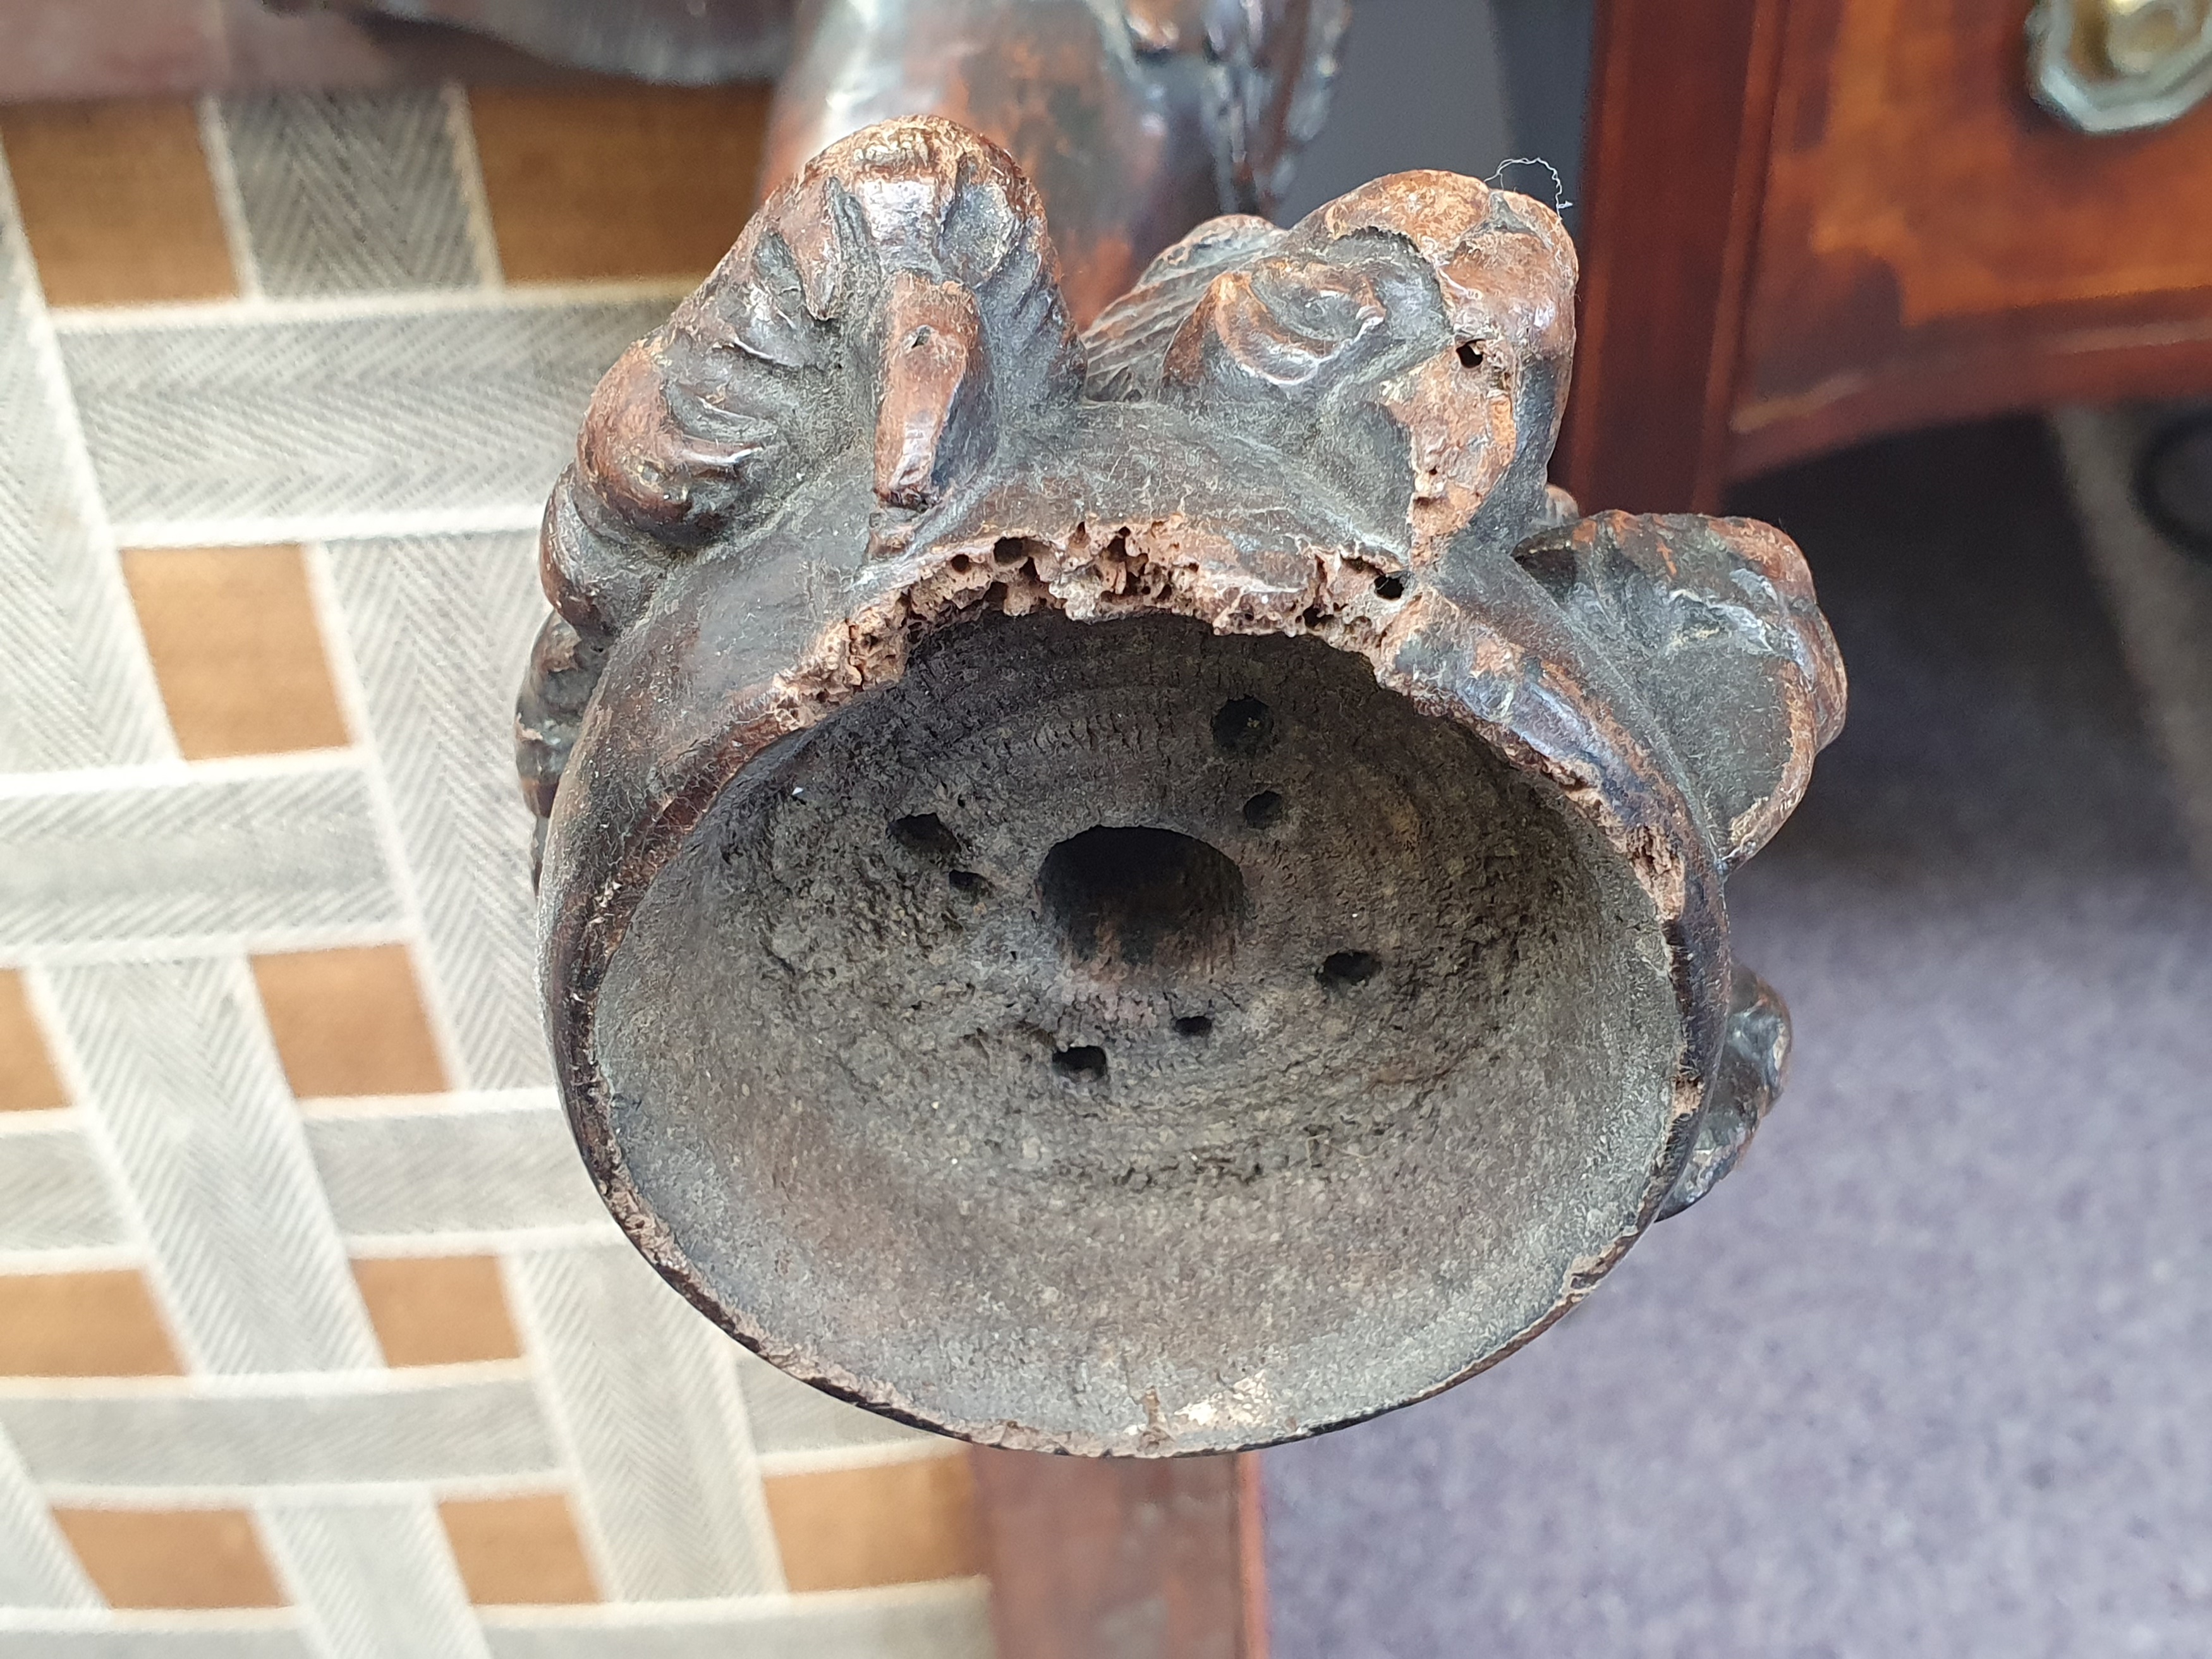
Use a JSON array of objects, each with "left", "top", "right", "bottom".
[{"left": 1086, "top": 173, "right": 1575, "bottom": 564}]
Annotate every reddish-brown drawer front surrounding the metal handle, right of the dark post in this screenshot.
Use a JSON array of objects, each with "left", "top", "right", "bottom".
[{"left": 1728, "top": 0, "right": 2212, "bottom": 476}]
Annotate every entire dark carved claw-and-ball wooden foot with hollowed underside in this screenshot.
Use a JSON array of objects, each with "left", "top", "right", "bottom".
[{"left": 520, "top": 119, "right": 1843, "bottom": 1455}]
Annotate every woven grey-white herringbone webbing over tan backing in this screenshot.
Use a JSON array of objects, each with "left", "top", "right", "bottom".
[{"left": 0, "top": 88, "right": 989, "bottom": 1659}]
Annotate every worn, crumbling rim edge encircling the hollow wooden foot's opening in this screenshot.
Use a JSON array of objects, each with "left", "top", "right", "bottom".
[{"left": 540, "top": 522, "right": 1725, "bottom": 1464}]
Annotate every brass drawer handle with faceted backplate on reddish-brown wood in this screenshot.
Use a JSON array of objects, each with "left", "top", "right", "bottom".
[{"left": 2029, "top": 0, "right": 2212, "bottom": 133}]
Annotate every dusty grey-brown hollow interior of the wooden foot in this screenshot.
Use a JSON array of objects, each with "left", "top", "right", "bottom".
[{"left": 597, "top": 615, "right": 1677, "bottom": 1451}]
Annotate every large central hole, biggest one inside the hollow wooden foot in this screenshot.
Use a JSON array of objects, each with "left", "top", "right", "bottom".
[{"left": 1038, "top": 825, "right": 1246, "bottom": 969}]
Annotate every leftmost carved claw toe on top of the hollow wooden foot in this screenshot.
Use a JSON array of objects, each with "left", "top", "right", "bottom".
[{"left": 522, "top": 119, "right": 1106, "bottom": 832}]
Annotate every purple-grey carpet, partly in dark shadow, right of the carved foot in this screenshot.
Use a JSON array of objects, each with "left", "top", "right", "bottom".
[{"left": 1265, "top": 423, "right": 2212, "bottom": 1659}]
